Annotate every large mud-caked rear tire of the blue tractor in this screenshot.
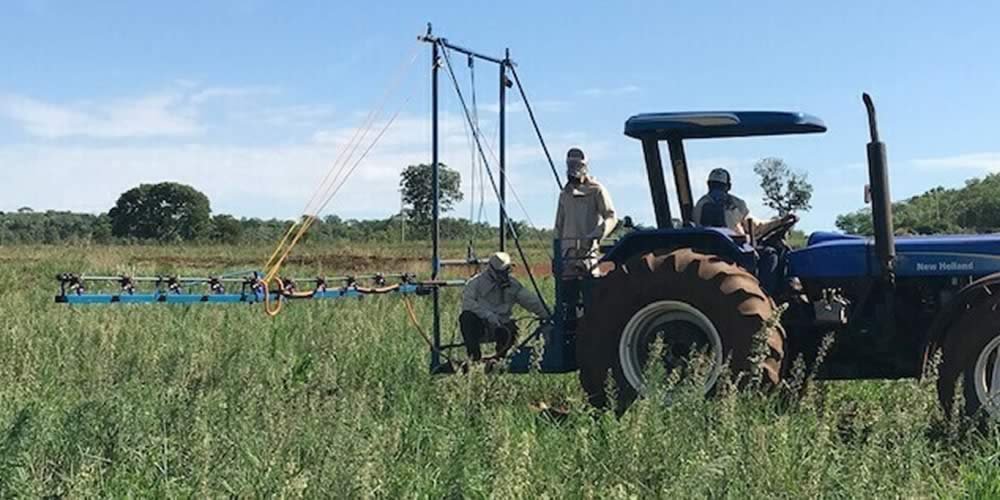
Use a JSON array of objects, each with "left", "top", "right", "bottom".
[{"left": 577, "top": 249, "right": 785, "bottom": 413}]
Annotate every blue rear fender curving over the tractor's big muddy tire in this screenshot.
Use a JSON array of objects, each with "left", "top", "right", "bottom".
[{"left": 601, "top": 227, "right": 754, "bottom": 269}]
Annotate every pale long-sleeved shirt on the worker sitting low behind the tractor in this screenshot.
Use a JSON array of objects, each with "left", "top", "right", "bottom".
[{"left": 462, "top": 271, "right": 548, "bottom": 324}]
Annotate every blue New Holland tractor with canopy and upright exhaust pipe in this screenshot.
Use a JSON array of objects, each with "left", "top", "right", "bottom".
[{"left": 564, "top": 95, "right": 1000, "bottom": 415}]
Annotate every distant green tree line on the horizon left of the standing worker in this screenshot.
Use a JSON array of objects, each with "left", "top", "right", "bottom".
[{"left": 0, "top": 165, "right": 551, "bottom": 245}]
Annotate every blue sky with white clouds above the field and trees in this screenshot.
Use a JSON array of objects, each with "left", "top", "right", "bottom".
[{"left": 0, "top": 0, "right": 1000, "bottom": 231}]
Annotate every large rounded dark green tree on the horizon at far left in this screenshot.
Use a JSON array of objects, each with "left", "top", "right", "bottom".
[{"left": 108, "top": 182, "right": 211, "bottom": 241}]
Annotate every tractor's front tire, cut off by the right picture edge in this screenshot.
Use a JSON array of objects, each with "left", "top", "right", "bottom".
[{"left": 937, "top": 298, "right": 1000, "bottom": 420}]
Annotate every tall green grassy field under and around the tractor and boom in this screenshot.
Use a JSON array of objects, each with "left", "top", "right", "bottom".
[{"left": 0, "top": 245, "right": 1000, "bottom": 498}]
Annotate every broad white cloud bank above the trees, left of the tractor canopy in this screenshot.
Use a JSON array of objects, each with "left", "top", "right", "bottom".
[{"left": 0, "top": 81, "right": 608, "bottom": 230}]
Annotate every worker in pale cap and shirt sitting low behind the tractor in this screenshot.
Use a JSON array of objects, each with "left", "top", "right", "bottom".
[{"left": 458, "top": 252, "right": 549, "bottom": 361}]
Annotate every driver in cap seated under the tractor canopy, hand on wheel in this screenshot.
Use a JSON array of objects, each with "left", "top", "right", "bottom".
[{"left": 691, "top": 168, "right": 798, "bottom": 236}]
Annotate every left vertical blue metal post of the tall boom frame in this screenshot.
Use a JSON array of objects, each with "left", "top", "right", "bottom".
[{"left": 428, "top": 39, "right": 441, "bottom": 371}]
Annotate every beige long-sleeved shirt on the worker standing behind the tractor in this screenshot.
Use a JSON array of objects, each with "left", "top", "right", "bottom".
[{"left": 555, "top": 177, "right": 618, "bottom": 275}]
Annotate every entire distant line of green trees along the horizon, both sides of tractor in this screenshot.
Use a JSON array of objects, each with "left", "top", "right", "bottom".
[{"left": 7, "top": 158, "right": 1000, "bottom": 245}]
